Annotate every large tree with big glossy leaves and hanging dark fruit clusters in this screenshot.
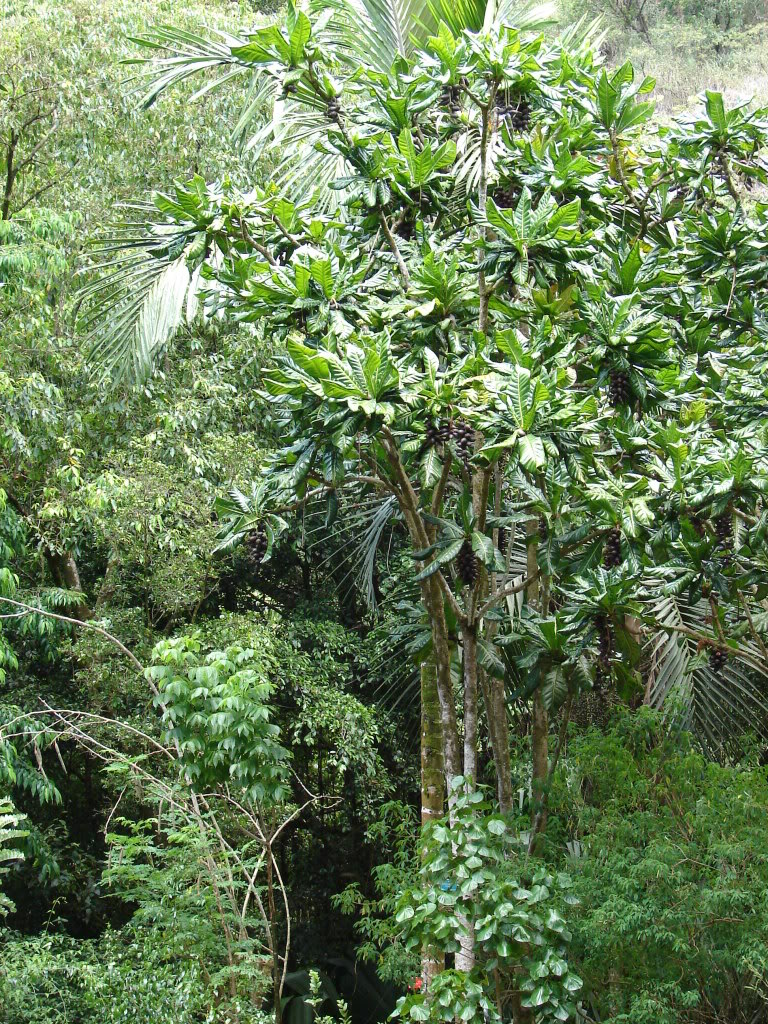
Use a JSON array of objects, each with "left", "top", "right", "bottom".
[{"left": 82, "top": 6, "right": 768, "bottom": 1020}]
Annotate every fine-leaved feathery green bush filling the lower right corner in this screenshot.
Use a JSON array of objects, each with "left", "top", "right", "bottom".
[{"left": 553, "top": 712, "right": 768, "bottom": 1024}]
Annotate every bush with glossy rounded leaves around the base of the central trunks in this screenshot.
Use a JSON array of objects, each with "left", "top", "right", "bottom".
[{"left": 395, "top": 778, "right": 582, "bottom": 1024}]
